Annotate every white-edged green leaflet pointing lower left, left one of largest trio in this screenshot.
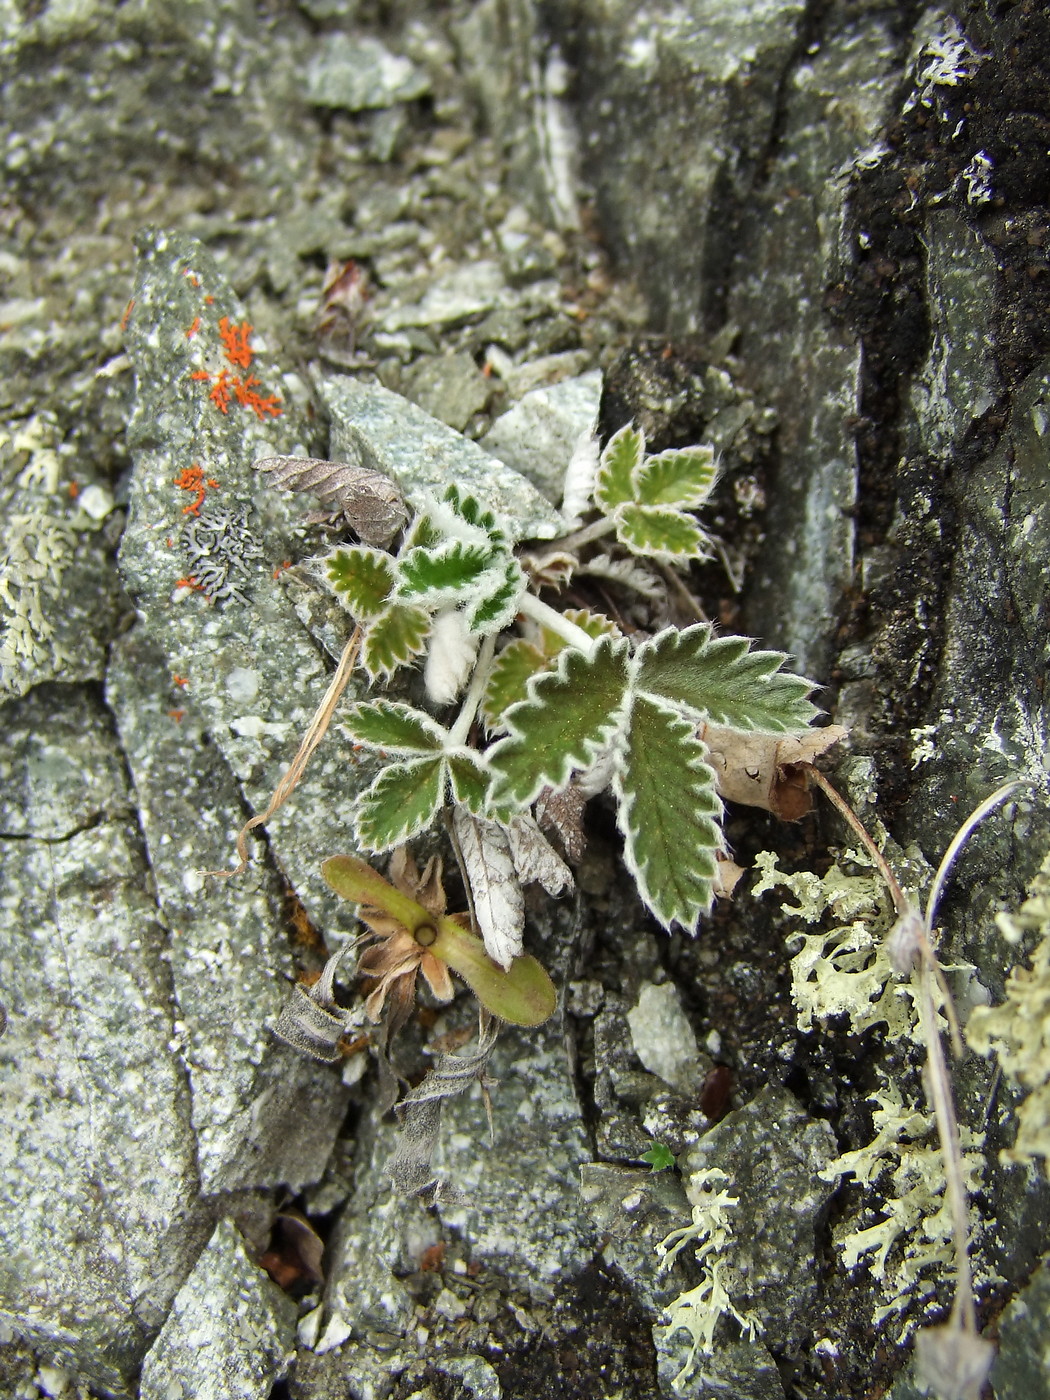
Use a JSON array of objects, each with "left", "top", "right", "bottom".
[{"left": 486, "top": 637, "right": 627, "bottom": 809}]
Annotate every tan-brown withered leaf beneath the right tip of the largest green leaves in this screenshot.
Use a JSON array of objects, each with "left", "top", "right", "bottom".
[{"left": 700, "top": 724, "right": 847, "bottom": 822}]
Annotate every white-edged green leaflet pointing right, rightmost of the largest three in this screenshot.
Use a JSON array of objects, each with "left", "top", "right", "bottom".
[{"left": 634, "top": 623, "right": 819, "bottom": 734}]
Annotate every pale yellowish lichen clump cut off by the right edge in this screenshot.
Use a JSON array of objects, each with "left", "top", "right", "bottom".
[{"left": 966, "top": 851, "right": 1050, "bottom": 1176}]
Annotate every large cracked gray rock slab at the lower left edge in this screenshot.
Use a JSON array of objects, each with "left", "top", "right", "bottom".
[{"left": 0, "top": 686, "right": 210, "bottom": 1393}]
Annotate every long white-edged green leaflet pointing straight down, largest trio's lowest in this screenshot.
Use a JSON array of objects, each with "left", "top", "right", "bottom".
[{"left": 613, "top": 696, "right": 722, "bottom": 934}]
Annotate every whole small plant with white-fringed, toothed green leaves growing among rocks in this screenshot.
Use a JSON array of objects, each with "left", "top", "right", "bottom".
[{"left": 316, "top": 426, "right": 818, "bottom": 985}]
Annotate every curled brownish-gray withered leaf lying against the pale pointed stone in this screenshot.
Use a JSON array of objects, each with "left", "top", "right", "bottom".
[{"left": 255, "top": 441, "right": 409, "bottom": 549}]
